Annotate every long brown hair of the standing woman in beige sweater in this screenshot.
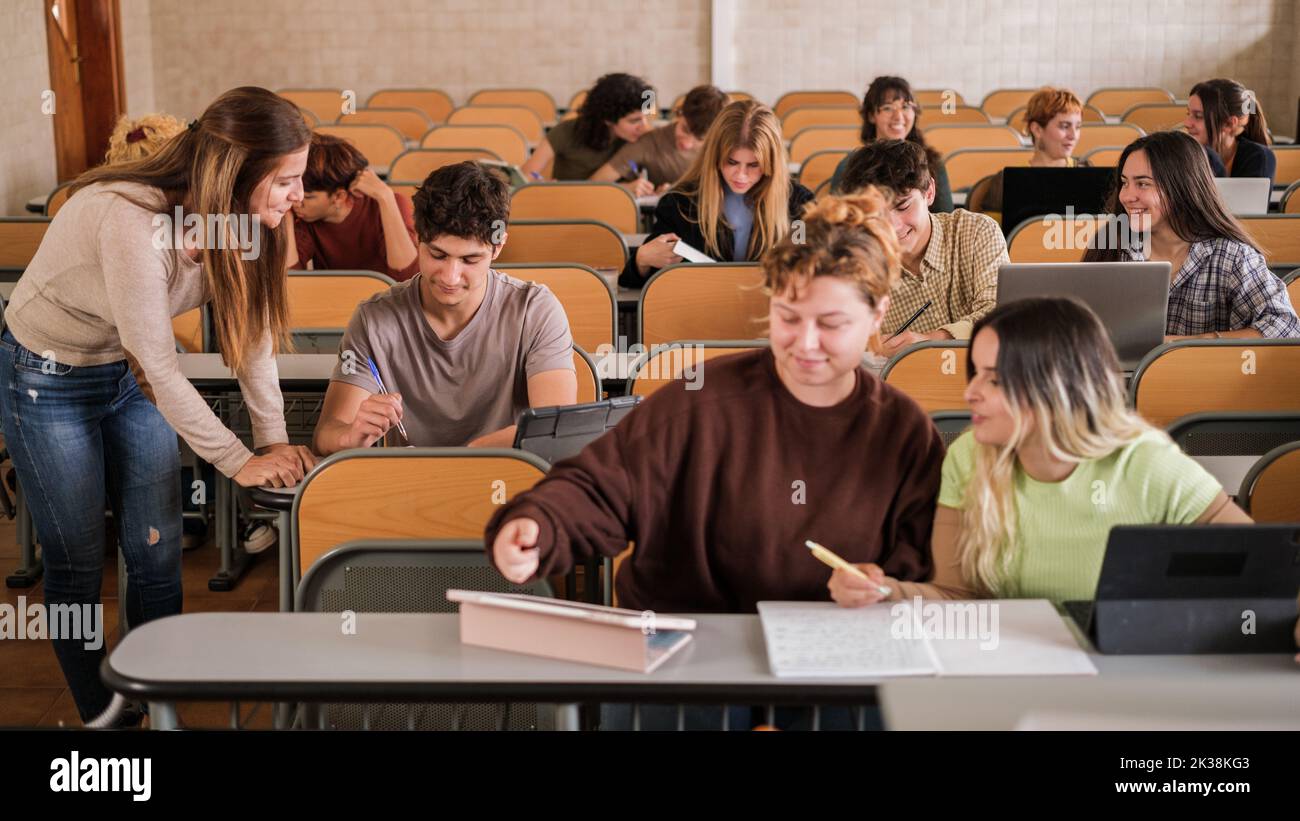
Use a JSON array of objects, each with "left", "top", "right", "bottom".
[{"left": 70, "top": 86, "right": 311, "bottom": 370}]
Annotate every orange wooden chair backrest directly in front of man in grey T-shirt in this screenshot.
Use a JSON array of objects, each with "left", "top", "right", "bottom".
[{"left": 291, "top": 448, "right": 547, "bottom": 578}]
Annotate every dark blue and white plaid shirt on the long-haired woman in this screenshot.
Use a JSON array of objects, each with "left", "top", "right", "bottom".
[{"left": 1128, "top": 238, "right": 1300, "bottom": 339}]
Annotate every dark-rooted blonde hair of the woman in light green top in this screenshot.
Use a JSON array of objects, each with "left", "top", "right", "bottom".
[{"left": 957, "top": 297, "right": 1156, "bottom": 596}]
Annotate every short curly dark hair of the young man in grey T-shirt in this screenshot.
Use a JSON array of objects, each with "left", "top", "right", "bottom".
[{"left": 412, "top": 161, "right": 510, "bottom": 246}]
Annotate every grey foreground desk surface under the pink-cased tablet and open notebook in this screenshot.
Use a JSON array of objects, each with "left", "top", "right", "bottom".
[{"left": 103, "top": 613, "right": 1300, "bottom": 729}]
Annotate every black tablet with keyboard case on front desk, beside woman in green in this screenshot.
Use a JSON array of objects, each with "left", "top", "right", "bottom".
[{"left": 1065, "top": 524, "right": 1300, "bottom": 655}]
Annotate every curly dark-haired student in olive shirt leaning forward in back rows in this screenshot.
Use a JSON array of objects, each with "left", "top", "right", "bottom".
[{"left": 520, "top": 74, "right": 655, "bottom": 179}]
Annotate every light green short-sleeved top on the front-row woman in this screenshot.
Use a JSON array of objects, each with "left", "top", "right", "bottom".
[{"left": 939, "top": 431, "right": 1222, "bottom": 604}]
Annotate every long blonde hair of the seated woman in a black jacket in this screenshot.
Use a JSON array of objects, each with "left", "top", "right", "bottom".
[{"left": 677, "top": 100, "right": 792, "bottom": 260}]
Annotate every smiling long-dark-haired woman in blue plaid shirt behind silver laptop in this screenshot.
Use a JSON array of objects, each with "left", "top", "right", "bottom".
[{"left": 1084, "top": 131, "right": 1300, "bottom": 340}]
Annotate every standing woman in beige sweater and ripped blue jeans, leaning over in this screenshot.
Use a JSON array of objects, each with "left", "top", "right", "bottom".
[{"left": 0, "top": 87, "right": 315, "bottom": 724}]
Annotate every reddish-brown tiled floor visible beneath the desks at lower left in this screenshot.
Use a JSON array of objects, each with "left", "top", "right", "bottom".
[{"left": 0, "top": 517, "right": 278, "bottom": 727}]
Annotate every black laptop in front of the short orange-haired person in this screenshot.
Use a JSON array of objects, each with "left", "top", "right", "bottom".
[{"left": 1002, "top": 168, "right": 1115, "bottom": 235}]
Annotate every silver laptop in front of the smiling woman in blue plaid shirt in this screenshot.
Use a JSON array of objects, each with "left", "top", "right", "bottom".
[{"left": 997, "top": 262, "right": 1171, "bottom": 370}]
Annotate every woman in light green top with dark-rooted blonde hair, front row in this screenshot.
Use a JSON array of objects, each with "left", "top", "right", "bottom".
[{"left": 829, "top": 297, "right": 1251, "bottom": 607}]
